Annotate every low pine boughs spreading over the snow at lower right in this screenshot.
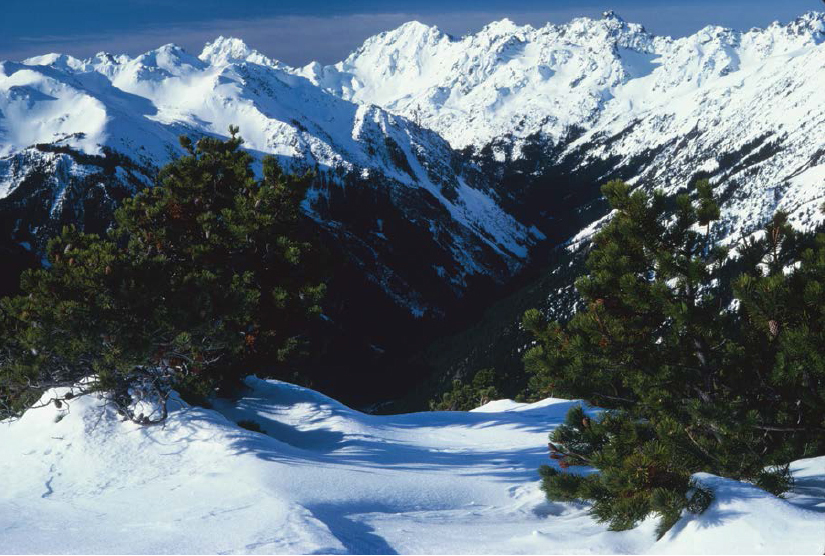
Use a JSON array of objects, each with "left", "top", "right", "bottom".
[{"left": 540, "top": 406, "right": 712, "bottom": 536}]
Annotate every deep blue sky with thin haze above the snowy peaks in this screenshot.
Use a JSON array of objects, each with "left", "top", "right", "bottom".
[{"left": 0, "top": 0, "right": 825, "bottom": 65}]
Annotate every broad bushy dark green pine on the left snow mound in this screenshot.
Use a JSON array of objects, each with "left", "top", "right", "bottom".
[{"left": 0, "top": 128, "right": 324, "bottom": 421}]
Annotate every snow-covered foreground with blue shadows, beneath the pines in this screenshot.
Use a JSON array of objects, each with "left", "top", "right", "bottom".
[{"left": 0, "top": 378, "right": 825, "bottom": 554}]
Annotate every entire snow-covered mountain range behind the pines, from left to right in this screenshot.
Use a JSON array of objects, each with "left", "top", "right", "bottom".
[{"left": 0, "top": 8, "right": 825, "bottom": 315}]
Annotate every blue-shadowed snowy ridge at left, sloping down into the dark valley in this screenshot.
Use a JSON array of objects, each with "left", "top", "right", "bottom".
[{"left": 0, "top": 37, "right": 540, "bottom": 312}]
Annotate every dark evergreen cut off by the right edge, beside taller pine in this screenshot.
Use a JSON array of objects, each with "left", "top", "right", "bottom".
[{"left": 734, "top": 212, "right": 825, "bottom": 459}]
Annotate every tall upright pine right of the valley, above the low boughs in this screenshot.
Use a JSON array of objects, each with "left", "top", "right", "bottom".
[{"left": 524, "top": 182, "right": 729, "bottom": 416}]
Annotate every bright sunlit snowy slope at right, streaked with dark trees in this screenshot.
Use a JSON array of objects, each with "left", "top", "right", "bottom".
[{"left": 569, "top": 13, "right": 825, "bottom": 243}]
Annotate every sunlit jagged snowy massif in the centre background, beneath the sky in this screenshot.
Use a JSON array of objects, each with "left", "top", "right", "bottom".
[{"left": 300, "top": 11, "right": 655, "bottom": 148}]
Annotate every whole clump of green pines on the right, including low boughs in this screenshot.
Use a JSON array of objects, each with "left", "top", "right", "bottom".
[{"left": 523, "top": 181, "right": 825, "bottom": 533}]
